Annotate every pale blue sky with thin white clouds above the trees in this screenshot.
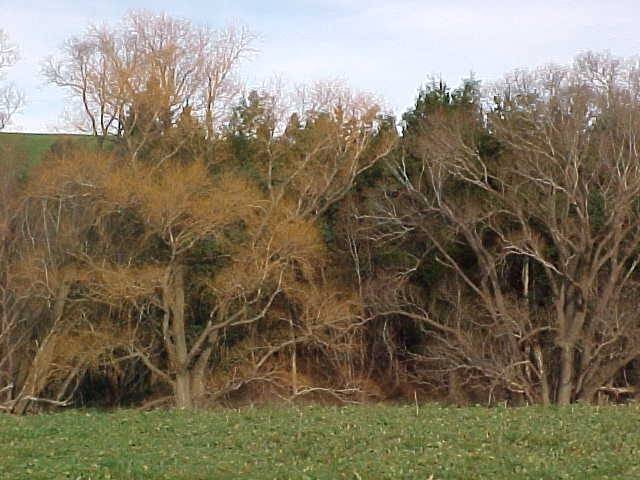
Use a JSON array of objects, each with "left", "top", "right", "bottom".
[{"left": 0, "top": 0, "right": 640, "bottom": 132}]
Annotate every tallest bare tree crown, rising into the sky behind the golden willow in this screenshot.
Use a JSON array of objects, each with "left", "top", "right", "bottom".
[{"left": 43, "top": 11, "right": 256, "bottom": 155}]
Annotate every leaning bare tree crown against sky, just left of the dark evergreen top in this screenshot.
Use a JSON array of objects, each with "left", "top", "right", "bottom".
[{"left": 244, "top": 80, "right": 397, "bottom": 218}]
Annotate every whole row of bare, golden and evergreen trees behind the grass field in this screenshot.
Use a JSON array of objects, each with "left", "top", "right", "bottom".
[{"left": 0, "top": 12, "right": 640, "bottom": 413}]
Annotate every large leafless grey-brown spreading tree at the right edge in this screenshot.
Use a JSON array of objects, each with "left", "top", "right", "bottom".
[{"left": 370, "top": 54, "right": 640, "bottom": 405}]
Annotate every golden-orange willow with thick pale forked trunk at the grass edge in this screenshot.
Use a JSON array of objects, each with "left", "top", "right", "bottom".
[{"left": 15, "top": 117, "right": 392, "bottom": 408}]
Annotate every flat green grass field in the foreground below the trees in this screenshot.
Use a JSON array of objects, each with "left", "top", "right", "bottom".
[{"left": 0, "top": 406, "right": 640, "bottom": 480}]
